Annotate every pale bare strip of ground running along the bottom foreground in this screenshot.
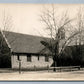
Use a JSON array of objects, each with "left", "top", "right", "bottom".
[{"left": 0, "top": 70, "right": 84, "bottom": 81}]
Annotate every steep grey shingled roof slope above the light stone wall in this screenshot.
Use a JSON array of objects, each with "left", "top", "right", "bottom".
[{"left": 3, "top": 31, "right": 50, "bottom": 53}]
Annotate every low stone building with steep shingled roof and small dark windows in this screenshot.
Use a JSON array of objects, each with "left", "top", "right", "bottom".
[{"left": 1, "top": 31, "right": 53, "bottom": 69}]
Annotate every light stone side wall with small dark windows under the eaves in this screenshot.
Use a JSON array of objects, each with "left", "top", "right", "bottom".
[{"left": 11, "top": 55, "right": 53, "bottom": 69}]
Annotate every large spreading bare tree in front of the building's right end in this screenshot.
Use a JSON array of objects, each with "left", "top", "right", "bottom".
[{"left": 40, "top": 5, "right": 82, "bottom": 71}]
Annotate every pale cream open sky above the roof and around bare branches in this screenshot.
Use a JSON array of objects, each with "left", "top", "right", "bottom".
[{"left": 0, "top": 4, "right": 80, "bottom": 36}]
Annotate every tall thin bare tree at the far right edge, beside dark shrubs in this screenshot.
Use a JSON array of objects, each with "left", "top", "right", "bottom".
[{"left": 72, "top": 5, "right": 84, "bottom": 62}]
